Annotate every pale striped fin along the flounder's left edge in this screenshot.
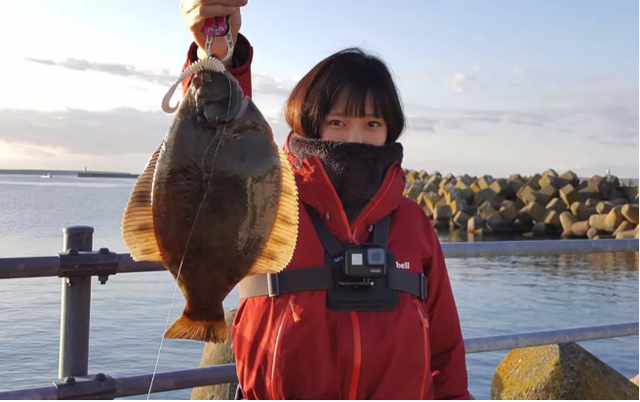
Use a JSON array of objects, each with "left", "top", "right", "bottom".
[{"left": 122, "top": 145, "right": 162, "bottom": 262}]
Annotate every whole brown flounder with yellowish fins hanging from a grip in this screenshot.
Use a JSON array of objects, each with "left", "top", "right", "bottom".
[{"left": 122, "top": 57, "right": 298, "bottom": 343}]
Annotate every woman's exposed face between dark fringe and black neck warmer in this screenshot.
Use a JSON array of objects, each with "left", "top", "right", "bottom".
[{"left": 320, "top": 92, "right": 387, "bottom": 146}]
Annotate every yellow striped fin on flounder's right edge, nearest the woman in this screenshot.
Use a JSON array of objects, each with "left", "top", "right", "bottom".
[{"left": 247, "top": 150, "right": 299, "bottom": 275}]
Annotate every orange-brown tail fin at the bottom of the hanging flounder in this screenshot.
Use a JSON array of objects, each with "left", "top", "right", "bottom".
[{"left": 164, "top": 314, "right": 229, "bottom": 343}]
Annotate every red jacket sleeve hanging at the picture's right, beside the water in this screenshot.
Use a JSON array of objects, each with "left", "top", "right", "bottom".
[{"left": 425, "top": 220, "right": 471, "bottom": 399}]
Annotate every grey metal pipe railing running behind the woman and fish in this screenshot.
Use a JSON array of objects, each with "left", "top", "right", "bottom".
[{"left": 0, "top": 226, "right": 639, "bottom": 400}]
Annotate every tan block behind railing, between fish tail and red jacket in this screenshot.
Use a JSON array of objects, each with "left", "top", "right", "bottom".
[{"left": 191, "top": 310, "right": 238, "bottom": 400}]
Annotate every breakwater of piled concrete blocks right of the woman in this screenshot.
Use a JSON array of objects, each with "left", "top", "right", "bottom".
[{"left": 404, "top": 169, "right": 638, "bottom": 239}]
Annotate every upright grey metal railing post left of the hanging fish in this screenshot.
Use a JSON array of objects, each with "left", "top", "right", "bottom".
[{"left": 58, "top": 226, "right": 93, "bottom": 378}]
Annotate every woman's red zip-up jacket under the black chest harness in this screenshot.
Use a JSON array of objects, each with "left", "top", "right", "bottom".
[{"left": 180, "top": 38, "right": 470, "bottom": 399}]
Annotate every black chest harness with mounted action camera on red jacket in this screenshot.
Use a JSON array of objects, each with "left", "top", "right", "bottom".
[{"left": 239, "top": 205, "right": 427, "bottom": 311}]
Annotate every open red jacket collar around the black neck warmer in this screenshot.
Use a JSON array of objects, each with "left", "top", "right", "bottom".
[{"left": 283, "top": 132, "right": 405, "bottom": 243}]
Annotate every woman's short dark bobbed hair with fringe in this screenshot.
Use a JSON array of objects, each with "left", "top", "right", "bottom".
[{"left": 284, "top": 48, "right": 405, "bottom": 144}]
